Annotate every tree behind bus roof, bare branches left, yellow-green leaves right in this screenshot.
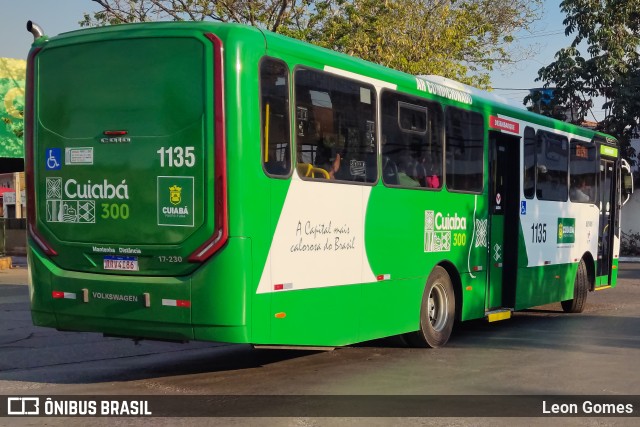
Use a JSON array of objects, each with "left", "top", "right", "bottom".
[{"left": 81, "top": 0, "right": 542, "bottom": 87}]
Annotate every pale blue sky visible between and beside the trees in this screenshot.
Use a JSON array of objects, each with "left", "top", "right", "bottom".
[{"left": 0, "top": 0, "right": 603, "bottom": 119}]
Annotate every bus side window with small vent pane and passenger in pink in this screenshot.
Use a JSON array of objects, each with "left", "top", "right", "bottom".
[{"left": 381, "top": 90, "right": 443, "bottom": 189}]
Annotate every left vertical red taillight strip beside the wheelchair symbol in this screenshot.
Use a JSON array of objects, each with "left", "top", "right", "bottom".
[{"left": 24, "top": 48, "right": 58, "bottom": 256}]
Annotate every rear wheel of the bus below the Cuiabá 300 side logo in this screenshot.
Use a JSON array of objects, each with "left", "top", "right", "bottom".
[{"left": 405, "top": 266, "right": 456, "bottom": 348}]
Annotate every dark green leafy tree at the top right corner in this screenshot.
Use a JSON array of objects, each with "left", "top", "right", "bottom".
[{"left": 538, "top": 0, "right": 640, "bottom": 153}]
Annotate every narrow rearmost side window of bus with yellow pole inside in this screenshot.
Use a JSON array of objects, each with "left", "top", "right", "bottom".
[{"left": 260, "top": 58, "right": 291, "bottom": 177}]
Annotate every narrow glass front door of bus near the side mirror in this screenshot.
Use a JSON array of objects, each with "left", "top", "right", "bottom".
[{"left": 596, "top": 158, "right": 616, "bottom": 287}]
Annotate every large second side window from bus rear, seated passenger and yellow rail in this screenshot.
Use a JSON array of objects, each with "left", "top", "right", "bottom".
[{"left": 294, "top": 68, "right": 378, "bottom": 183}]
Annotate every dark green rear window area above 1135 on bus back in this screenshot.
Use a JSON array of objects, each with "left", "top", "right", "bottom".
[{"left": 38, "top": 37, "right": 207, "bottom": 138}]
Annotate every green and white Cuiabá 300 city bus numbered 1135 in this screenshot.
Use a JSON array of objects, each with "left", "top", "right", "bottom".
[{"left": 25, "top": 22, "right": 630, "bottom": 347}]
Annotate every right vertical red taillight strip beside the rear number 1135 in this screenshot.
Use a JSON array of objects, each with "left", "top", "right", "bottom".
[{"left": 189, "top": 33, "right": 229, "bottom": 262}]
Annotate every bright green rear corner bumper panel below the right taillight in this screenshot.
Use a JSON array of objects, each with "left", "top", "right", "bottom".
[{"left": 191, "top": 238, "right": 252, "bottom": 342}]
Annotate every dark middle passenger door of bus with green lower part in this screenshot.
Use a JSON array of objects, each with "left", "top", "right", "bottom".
[{"left": 485, "top": 131, "right": 520, "bottom": 310}]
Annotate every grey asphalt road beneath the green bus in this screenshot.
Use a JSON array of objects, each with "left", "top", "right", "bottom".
[{"left": 0, "top": 263, "right": 640, "bottom": 427}]
